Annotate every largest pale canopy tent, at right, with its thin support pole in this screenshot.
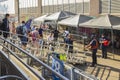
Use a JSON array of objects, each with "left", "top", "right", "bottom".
[{"left": 79, "top": 14, "right": 120, "bottom": 58}]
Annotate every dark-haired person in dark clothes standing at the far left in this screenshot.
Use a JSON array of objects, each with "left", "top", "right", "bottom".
[{"left": 2, "top": 14, "right": 10, "bottom": 38}]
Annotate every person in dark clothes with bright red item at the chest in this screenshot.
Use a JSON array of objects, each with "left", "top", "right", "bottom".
[{"left": 100, "top": 34, "right": 109, "bottom": 59}]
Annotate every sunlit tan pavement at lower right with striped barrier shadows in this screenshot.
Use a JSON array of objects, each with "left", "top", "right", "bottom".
[{"left": 74, "top": 50, "right": 120, "bottom": 80}]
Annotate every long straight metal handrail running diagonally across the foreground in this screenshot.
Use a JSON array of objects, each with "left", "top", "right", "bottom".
[{"left": 0, "top": 37, "right": 69, "bottom": 80}]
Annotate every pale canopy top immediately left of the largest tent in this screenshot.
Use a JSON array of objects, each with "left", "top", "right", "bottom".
[{"left": 58, "top": 15, "right": 92, "bottom": 27}]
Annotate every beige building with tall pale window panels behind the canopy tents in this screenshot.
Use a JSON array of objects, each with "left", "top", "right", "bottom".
[{"left": 15, "top": 0, "right": 120, "bottom": 20}]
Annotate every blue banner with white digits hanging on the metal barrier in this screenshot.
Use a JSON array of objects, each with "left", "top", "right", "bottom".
[{"left": 52, "top": 57, "right": 64, "bottom": 80}]
